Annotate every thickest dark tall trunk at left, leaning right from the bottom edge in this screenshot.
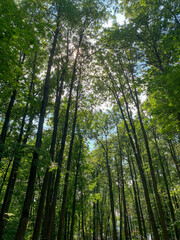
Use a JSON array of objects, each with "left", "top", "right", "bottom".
[{"left": 15, "top": 22, "right": 59, "bottom": 240}]
